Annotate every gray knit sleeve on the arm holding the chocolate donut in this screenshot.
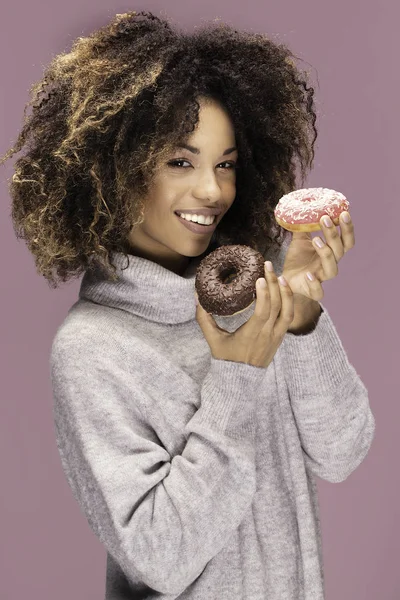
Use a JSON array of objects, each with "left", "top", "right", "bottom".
[{"left": 50, "top": 332, "right": 265, "bottom": 597}]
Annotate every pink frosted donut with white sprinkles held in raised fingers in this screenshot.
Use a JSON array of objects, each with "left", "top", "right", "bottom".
[{"left": 274, "top": 188, "right": 350, "bottom": 231}]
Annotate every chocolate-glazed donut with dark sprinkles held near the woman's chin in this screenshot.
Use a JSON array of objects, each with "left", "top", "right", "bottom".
[{"left": 195, "top": 244, "right": 265, "bottom": 317}]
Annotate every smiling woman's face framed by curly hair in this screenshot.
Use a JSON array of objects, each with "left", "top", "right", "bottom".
[{"left": 128, "top": 100, "right": 238, "bottom": 275}]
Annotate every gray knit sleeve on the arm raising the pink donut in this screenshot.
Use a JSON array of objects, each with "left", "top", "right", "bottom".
[{"left": 282, "top": 303, "right": 375, "bottom": 483}]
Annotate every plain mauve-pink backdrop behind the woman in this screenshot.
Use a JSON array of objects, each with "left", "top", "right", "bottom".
[{"left": 0, "top": 0, "right": 400, "bottom": 600}]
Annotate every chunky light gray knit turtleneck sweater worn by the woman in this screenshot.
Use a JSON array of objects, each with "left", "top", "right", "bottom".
[{"left": 50, "top": 241, "right": 375, "bottom": 600}]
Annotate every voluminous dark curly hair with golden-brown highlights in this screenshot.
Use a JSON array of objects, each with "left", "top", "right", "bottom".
[{"left": 0, "top": 11, "right": 317, "bottom": 287}]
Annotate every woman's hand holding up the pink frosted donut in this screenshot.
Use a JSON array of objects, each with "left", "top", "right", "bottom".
[{"left": 282, "top": 212, "right": 355, "bottom": 303}]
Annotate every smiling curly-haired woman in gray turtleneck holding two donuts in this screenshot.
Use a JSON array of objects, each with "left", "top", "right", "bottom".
[{"left": 3, "top": 12, "right": 375, "bottom": 600}]
